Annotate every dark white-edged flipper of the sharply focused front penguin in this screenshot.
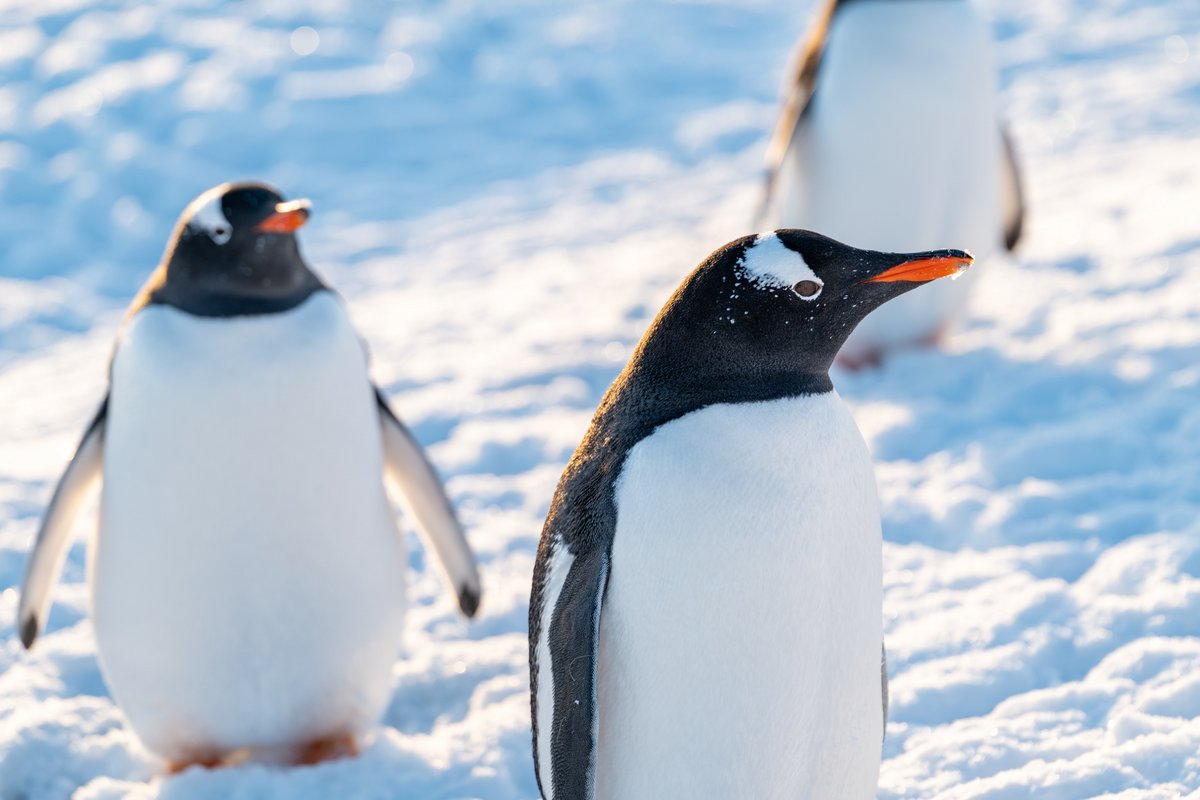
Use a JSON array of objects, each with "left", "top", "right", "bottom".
[{"left": 529, "top": 541, "right": 608, "bottom": 800}]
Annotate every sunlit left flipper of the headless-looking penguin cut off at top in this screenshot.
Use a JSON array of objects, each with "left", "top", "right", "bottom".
[{"left": 754, "top": 0, "right": 842, "bottom": 230}]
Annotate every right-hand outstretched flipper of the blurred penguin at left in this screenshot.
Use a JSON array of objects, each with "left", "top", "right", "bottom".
[{"left": 374, "top": 387, "right": 482, "bottom": 616}]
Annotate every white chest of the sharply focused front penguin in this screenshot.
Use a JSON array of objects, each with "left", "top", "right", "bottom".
[{"left": 596, "top": 392, "right": 883, "bottom": 800}]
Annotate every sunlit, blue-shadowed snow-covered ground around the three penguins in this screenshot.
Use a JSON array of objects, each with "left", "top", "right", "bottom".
[{"left": 0, "top": 0, "right": 1200, "bottom": 800}]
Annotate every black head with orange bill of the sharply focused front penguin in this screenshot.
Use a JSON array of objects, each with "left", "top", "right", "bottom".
[{"left": 640, "top": 230, "right": 973, "bottom": 395}]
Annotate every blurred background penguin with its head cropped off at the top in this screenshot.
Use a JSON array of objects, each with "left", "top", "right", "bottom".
[{"left": 757, "top": 0, "right": 1025, "bottom": 368}]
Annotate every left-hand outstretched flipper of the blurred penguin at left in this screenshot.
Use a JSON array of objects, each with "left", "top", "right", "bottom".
[{"left": 17, "top": 396, "right": 108, "bottom": 650}]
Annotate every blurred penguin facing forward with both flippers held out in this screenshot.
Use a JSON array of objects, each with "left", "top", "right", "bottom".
[{"left": 18, "top": 182, "right": 481, "bottom": 771}]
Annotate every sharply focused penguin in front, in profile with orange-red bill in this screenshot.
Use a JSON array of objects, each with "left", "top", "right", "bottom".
[{"left": 529, "top": 229, "right": 972, "bottom": 800}]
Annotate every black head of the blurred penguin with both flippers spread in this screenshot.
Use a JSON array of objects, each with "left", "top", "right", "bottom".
[{"left": 155, "top": 182, "right": 323, "bottom": 315}]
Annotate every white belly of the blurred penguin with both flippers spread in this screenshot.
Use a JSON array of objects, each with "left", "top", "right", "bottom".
[{"left": 91, "top": 293, "right": 406, "bottom": 758}]
